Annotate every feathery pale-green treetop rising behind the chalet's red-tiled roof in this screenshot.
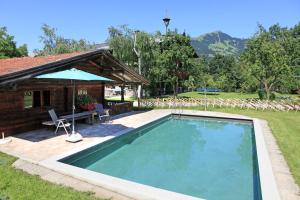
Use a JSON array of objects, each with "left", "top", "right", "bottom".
[{"left": 34, "top": 24, "right": 95, "bottom": 56}]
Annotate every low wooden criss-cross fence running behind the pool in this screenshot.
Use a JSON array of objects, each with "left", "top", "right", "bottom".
[{"left": 140, "top": 98, "right": 300, "bottom": 111}]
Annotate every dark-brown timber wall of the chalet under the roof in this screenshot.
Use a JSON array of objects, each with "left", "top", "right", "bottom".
[{"left": 0, "top": 80, "right": 104, "bottom": 136}]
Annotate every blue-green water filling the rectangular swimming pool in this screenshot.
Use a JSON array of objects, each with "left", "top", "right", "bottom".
[{"left": 61, "top": 117, "right": 260, "bottom": 200}]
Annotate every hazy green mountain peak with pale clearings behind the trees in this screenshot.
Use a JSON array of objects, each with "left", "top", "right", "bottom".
[{"left": 191, "top": 31, "right": 247, "bottom": 57}]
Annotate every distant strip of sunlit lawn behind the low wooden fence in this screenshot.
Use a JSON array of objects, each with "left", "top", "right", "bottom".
[{"left": 178, "top": 92, "right": 297, "bottom": 99}]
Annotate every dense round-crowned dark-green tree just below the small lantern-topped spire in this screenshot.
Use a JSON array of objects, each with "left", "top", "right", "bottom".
[{"left": 158, "top": 32, "right": 195, "bottom": 96}]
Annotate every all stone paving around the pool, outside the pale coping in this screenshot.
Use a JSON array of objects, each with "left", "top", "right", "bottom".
[{"left": 0, "top": 110, "right": 300, "bottom": 200}]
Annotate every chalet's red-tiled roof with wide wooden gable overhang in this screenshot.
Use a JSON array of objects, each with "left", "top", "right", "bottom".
[{"left": 0, "top": 49, "right": 149, "bottom": 85}]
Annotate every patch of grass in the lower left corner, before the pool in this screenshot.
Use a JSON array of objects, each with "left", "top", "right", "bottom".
[{"left": 0, "top": 152, "right": 99, "bottom": 200}]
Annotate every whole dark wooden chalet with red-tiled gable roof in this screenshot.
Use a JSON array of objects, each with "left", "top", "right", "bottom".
[{"left": 0, "top": 49, "right": 149, "bottom": 136}]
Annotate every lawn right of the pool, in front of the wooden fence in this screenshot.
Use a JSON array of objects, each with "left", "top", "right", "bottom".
[{"left": 157, "top": 107, "right": 300, "bottom": 186}]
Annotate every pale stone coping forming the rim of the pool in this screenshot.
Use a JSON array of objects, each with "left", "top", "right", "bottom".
[{"left": 38, "top": 111, "right": 280, "bottom": 200}]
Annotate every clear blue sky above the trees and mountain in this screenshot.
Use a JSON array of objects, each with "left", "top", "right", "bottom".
[{"left": 0, "top": 0, "right": 300, "bottom": 51}]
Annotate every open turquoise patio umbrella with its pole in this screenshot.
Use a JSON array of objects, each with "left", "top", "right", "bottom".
[{"left": 35, "top": 68, "right": 112, "bottom": 140}]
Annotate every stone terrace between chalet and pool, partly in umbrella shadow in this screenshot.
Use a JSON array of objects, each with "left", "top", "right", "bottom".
[{"left": 0, "top": 110, "right": 170, "bottom": 162}]
